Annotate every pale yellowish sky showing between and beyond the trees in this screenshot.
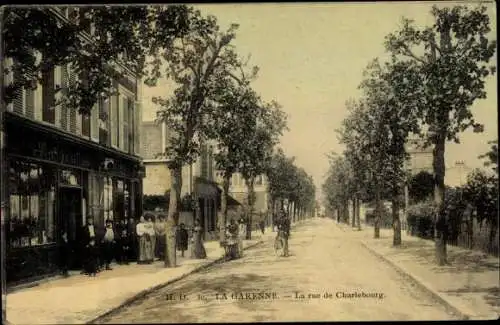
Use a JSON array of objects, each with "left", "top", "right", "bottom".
[{"left": 143, "top": 1, "right": 497, "bottom": 199}]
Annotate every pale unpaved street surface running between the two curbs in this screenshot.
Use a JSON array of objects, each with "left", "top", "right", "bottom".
[{"left": 101, "top": 219, "right": 456, "bottom": 323}]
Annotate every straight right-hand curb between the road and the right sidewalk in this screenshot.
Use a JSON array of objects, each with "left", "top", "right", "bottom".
[{"left": 361, "top": 241, "right": 472, "bottom": 320}]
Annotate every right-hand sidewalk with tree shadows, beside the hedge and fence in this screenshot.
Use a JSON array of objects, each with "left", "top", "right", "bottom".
[{"left": 338, "top": 224, "right": 500, "bottom": 319}]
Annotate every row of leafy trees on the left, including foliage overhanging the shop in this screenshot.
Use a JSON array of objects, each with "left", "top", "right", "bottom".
[{"left": 2, "top": 5, "right": 313, "bottom": 267}]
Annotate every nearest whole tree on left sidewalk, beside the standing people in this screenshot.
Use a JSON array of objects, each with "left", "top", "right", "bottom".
[{"left": 153, "top": 12, "right": 238, "bottom": 267}]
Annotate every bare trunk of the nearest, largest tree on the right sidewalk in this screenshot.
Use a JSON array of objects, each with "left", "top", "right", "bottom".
[{"left": 433, "top": 135, "right": 448, "bottom": 265}]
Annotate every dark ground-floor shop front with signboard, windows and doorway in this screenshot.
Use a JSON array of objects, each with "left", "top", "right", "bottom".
[{"left": 3, "top": 114, "right": 142, "bottom": 283}]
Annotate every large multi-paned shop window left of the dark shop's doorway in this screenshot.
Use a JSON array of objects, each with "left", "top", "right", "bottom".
[{"left": 8, "top": 161, "right": 56, "bottom": 247}]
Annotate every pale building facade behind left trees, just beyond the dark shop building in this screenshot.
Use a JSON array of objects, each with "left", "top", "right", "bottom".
[{"left": 141, "top": 121, "right": 220, "bottom": 240}]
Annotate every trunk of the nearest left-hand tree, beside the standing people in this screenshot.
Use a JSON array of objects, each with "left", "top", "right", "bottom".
[{"left": 165, "top": 166, "right": 182, "bottom": 267}]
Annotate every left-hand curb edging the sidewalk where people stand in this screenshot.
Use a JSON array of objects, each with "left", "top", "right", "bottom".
[{"left": 85, "top": 240, "right": 264, "bottom": 324}]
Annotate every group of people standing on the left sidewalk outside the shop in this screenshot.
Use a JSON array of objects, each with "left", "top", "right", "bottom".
[{"left": 64, "top": 214, "right": 207, "bottom": 276}]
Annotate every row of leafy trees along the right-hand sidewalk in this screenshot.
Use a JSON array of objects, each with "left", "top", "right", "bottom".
[{"left": 325, "top": 6, "right": 496, "bottom": 265}]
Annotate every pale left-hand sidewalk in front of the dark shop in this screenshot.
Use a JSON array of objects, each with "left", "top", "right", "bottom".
[{"left": 6, "top": 229, "right": 273, "bottom": 324}]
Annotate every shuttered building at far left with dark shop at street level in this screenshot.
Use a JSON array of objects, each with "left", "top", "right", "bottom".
[{"left": 2, "top": 9, "right": 143, "bottom": 282}]
